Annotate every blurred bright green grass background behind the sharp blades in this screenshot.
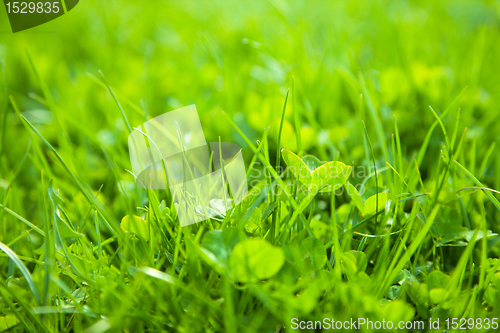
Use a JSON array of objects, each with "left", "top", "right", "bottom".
[{"left": 0, "top": 0, "right": 500, "bottom": 215}]
